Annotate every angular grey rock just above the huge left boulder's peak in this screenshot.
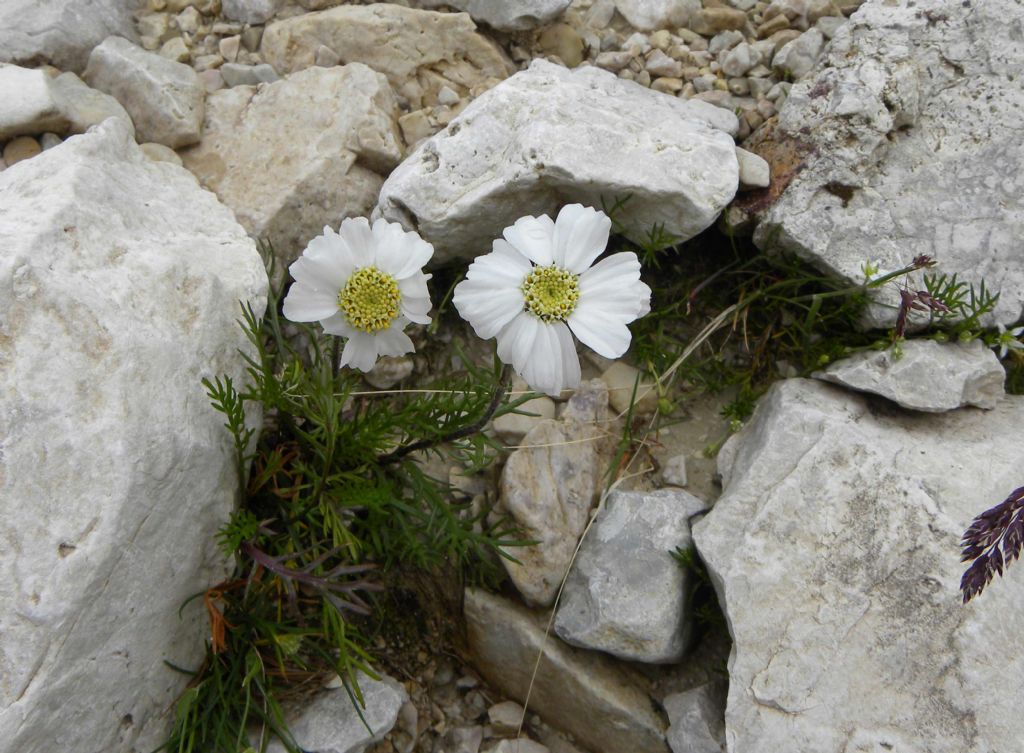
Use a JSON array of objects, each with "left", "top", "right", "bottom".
[{"left": 83, "top": 37, "right": 206, "bottom": 149}]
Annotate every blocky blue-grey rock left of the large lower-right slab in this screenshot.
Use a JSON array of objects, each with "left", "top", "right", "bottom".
[{"left": 555, "top": 489, "right": 705, "bottom": 664}]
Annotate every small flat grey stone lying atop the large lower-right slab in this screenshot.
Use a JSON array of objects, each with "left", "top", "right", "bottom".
[{"left": 814, "top": 340, "right": 1007, "bottom": 413}]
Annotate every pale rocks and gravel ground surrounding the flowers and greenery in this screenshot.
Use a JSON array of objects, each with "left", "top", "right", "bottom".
[{"left": 0, "top": 0, "right": 1024, "bottom": 753}]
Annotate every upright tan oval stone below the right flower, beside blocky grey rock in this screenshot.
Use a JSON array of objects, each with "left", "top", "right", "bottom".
[{"left": 500, "top": 377, "right": 608, "bottom": 605}]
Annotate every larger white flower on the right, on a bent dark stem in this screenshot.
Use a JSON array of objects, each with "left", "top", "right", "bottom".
[{"left": 453, "top": 204, "right": 650, "bottom": 395}]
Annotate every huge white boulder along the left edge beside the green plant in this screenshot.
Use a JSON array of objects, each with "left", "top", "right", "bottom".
[{"left": 0, "top": 120, "right": 266, "bottom": 753}]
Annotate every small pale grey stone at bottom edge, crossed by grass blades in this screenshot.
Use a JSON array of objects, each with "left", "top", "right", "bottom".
[{"left": 266, "top": 675, "right": 409, "bottom": 753}]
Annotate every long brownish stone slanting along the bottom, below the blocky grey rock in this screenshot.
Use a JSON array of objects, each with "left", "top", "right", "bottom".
[{"left": 464, "top": 588, "right": 668, "bottom": 753}]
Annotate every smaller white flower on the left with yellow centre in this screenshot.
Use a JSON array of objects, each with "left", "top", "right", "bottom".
[{"left": 284, "top": 217, "right": 434, "bottom": 371}]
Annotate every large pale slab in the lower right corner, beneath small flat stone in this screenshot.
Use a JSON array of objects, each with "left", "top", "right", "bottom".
[{"left": 693, "top": 379, "right": 1024, "bottom": 753}]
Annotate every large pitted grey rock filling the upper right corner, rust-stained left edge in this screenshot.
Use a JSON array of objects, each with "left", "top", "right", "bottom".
[{"left": 750, "top": 0, "right": 1024, "bottom": 327}]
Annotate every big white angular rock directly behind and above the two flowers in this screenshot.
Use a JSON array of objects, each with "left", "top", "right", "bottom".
[{"left": 378, "top": 59, "right": 738, "bottom": 263}]
